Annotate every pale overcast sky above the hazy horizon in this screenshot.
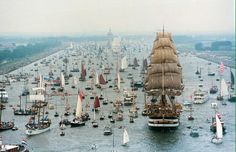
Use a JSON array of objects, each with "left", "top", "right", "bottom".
[{"left": 0, "top": 0, "right": 235, "bottom": 34}]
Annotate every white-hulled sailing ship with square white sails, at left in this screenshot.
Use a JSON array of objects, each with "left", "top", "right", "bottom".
[{"left": 25, "top": 75, "right": 51, "bottom": 136}]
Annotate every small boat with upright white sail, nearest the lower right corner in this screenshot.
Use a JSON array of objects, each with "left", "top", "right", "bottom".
[{"left": 211, "top": 115, "right": 223, "bottom": 144}]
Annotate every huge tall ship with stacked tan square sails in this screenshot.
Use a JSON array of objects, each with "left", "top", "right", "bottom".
[{"left": 143, "top": 29, "right": 184, "bottom": 128}]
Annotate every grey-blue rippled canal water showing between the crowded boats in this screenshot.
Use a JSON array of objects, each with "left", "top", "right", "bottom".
[{"left": 0, "top": 44, "right": 235, "bottom": 152}]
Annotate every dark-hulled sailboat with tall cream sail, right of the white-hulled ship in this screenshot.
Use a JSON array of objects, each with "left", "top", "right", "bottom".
[{"left": 70, "top": 95, "right": 85, "bottom": 127}]
